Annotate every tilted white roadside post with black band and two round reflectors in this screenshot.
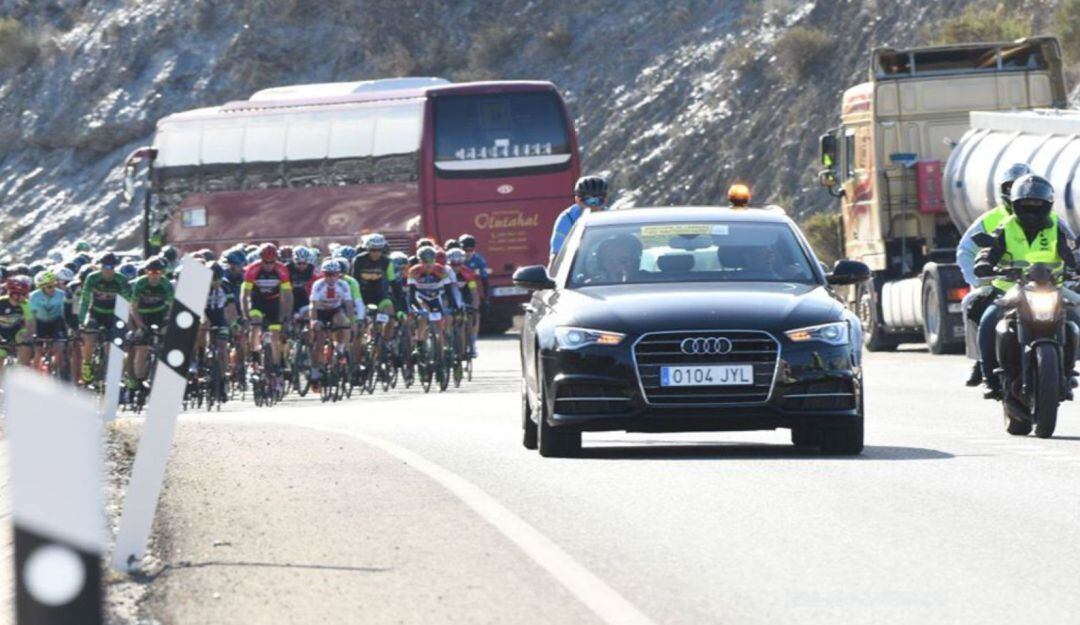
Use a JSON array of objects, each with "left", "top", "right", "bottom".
[{"left": 112, "top": 256, "right": 211, "bottom": 572}]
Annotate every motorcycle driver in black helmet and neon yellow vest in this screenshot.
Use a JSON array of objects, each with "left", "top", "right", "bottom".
[{"left": 974, "top": 174, "right": 1077, "bottom": 399}]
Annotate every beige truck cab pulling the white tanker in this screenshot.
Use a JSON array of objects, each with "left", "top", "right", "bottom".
[{"left": 819, "top": 37, "right": 1067, "bottom": 354}]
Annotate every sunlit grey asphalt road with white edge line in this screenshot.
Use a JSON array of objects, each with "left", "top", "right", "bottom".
[{"left": 10, "top": 340, "right": 1080, "bottom": 625}]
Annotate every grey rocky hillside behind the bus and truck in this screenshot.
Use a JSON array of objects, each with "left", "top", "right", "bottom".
[{"left": 0, "top": 0, "right": 1080, "bottom": 255}]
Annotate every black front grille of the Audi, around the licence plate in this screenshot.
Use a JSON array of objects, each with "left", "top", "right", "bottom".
[{"left": 634, "top": 330, "right": 780, "bottom": 406}]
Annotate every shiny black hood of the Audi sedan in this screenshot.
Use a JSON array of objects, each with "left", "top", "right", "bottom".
[{"left": 551, "top": 282, "right": 843, "bottom": 334}]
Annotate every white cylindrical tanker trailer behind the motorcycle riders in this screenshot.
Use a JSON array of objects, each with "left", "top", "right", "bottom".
[{"left": 942, "top": 109, "right": 1080, "bottom": 234}]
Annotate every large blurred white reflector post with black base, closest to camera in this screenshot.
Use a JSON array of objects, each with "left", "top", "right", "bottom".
[{"left": 4, "top": 368, "right": 105, "bottom": 625}]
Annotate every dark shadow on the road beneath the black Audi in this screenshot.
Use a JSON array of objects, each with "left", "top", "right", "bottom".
[{"left": 581, "top": 440, "right": 955, "bottom": 462}]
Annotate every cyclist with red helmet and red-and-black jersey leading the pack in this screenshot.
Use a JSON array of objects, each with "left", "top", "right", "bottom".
[{"left": 240, "top": 243, "right": 293, "bottom": 367}]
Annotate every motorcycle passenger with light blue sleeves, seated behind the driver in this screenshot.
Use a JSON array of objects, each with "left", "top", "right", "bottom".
[{"left": 956, "top": 163, "right": 1031, "bottom": 386}]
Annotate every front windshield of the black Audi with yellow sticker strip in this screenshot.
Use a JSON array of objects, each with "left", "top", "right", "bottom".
[{"left": 568, "top": 221, "right": 818, "bottom": 288}]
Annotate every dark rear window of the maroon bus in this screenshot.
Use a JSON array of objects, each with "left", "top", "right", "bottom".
[{"left": 434, "top": 92, "right": 570, "bottom": 177}]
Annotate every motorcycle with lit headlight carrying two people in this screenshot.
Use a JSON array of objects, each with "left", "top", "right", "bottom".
[{"left": 995, "top": 263, "right": 1080, "bottom": 438}]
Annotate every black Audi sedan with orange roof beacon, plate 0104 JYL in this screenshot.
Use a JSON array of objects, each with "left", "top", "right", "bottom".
[{"left": 514, "top": 207, "right": 869, "bottom": 457}]
